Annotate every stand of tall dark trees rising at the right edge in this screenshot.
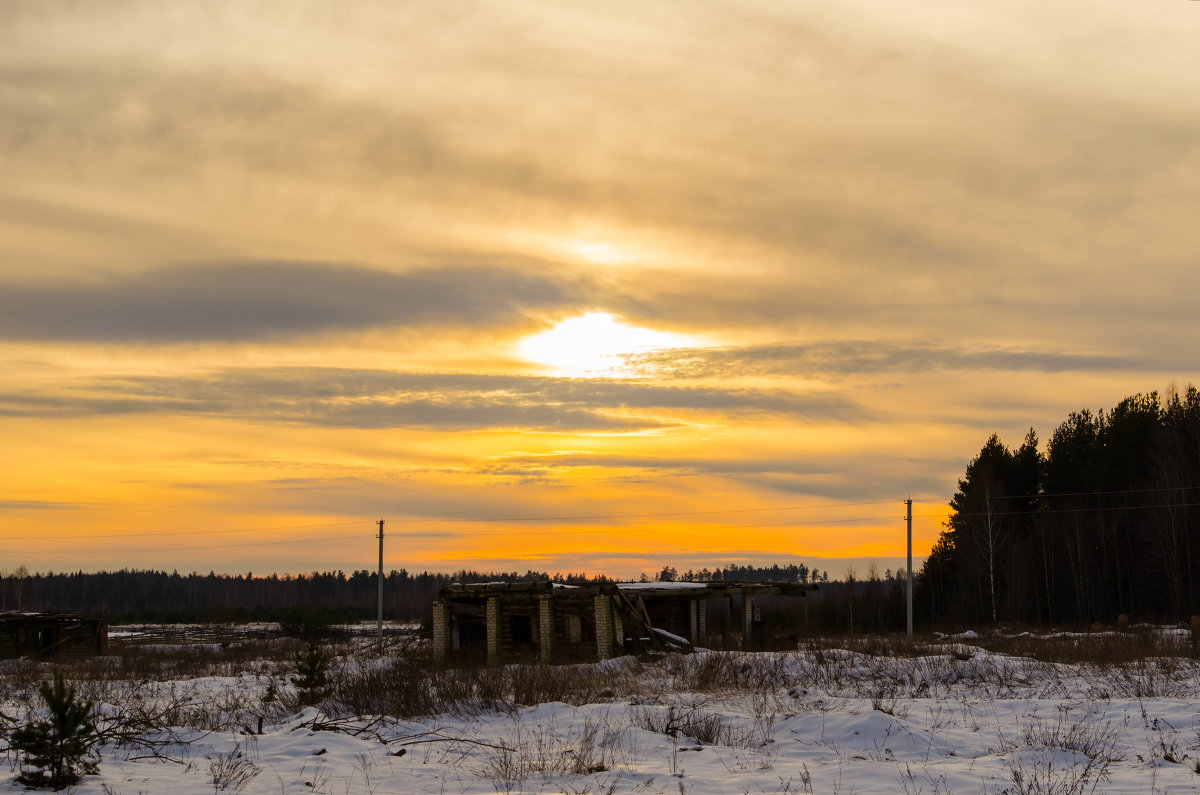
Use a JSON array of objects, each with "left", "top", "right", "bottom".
[{"left": 918, "top": 387, "right": 1200, "bottom": 626}]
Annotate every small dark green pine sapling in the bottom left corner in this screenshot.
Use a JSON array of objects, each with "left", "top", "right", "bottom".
[{"left": 8, "top": 673, "right": 100, "bottom": 790}]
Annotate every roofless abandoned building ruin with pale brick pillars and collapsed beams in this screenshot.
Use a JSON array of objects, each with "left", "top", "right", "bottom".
[{"left": 433, "top": 581, "right": 817, "bottom": 665}]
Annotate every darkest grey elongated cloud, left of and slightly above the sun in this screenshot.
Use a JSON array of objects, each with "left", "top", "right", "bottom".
[{"left": 0, "top": 262, "right": 582, "bottom": 345}]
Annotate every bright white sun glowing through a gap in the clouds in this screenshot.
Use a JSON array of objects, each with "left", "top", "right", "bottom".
[{"left": 517, "top": 312, "right": 696, "bottom": 375}]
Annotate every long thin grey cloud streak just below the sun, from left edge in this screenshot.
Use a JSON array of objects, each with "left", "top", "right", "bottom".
[{"left": 0, "top": 367, "right": 865, "bottom": 430}]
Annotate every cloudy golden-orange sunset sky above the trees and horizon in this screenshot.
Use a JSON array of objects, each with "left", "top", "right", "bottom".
[{"left": 0, "top": 0, "right": 1200, "bottom": 575}]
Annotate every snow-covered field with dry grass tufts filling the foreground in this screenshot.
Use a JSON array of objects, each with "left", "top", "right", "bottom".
[{"left": 0, "top": 635, "right": 1200, "bottom": 795}]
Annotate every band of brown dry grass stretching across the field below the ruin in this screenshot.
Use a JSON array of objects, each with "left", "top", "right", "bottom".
[{"left": 0, "top": 630, "right": 1198, "bottom": 736}]
